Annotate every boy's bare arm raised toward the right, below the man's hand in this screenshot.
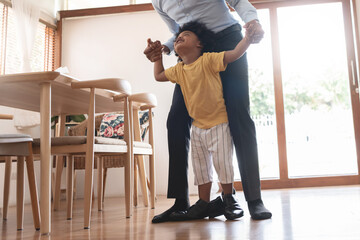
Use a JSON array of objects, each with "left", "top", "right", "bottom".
[{"left": 224, "top": 23, "right": 254, "bottom": 65}]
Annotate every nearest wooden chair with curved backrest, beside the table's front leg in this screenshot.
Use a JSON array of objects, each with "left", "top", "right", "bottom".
[{"left": 34, "top": 78, "right": 131, "bottom": 229}]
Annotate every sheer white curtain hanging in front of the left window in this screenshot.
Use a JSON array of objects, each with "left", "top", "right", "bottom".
[{"left": 12, "top": 0, "right": 40, "bottom": 129}]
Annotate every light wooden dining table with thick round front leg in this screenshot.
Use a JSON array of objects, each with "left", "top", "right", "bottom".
[{"left": 0, "top": 71, "right": 121, "bottom": 235}]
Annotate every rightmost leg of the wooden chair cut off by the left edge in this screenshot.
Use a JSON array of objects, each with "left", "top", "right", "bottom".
[{"left": 26, "top": 143, "right": 40, "bottom": 230}]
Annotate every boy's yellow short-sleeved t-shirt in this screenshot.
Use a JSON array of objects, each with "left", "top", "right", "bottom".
[{"left": 165, "top": 52, "right": 228, "bottom": 129}]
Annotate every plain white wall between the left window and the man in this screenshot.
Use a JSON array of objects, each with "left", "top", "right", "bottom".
[{"left": 62, "top": 11, "right": 196, "bottom": 196}]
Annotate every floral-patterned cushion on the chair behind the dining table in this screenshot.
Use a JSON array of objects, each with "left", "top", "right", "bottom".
[{"left": 99, "top": 111, "right": 153, "bottom": 140}]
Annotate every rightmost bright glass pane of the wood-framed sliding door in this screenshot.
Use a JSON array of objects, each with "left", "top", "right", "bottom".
[{"left": 277, "top": 2, "right": 358, "bottom": 178}]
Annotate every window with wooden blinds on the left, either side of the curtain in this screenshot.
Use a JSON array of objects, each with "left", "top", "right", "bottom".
[{"left": 0, "top": 3, "right": 55, "bottom": 74}]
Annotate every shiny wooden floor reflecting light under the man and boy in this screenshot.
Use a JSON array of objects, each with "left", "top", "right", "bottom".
[{"left": 1, "top": 185, "right": 360, "bottom": 240}]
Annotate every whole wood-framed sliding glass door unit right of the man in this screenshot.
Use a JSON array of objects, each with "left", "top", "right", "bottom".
[{"left": 234, "top": 0, "right": 360, "bottom": 188}]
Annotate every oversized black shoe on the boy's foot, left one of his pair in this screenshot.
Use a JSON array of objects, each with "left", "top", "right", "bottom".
[{"left": 169, "top": 199, "right": 209, "bottom": 221}]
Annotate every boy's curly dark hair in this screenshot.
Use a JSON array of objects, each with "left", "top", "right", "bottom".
[{"left": 175, "top": 21, "right": 215, "bottom": 59}]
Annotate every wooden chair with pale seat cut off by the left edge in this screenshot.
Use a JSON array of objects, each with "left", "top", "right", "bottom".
[{"left": 0, "top": 114, "right": 40, "bottom": 230}]
